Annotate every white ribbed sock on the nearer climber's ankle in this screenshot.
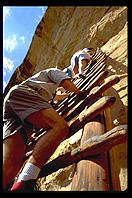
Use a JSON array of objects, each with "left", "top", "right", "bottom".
[{"left": 17, "top": 162, "right": 40, "bottom": 182}]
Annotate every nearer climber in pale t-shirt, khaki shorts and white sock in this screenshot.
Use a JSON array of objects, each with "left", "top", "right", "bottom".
[{"left": 3, "top": 68, "right": 82, "bottom": 192}]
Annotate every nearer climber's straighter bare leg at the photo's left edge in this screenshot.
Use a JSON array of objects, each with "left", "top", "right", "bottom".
[{"left": 3, "top": 132, "right": 25, "bottom": 189}]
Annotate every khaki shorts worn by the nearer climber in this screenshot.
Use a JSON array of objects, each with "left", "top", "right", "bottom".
[{"left": 3, "top": 85, "right": 52, "bottom": 142}]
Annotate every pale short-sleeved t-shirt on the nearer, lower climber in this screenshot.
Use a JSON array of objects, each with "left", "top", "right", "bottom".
[{"left": 21, "top": 68, "right": 71, "bottom": 101}]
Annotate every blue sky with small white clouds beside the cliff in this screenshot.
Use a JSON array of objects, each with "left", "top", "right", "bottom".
[{"left": 3, "top": 6, "right": 47, "bottom": 91}]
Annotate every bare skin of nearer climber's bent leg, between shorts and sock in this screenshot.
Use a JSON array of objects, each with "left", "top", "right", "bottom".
[{"left": 27, "top": 108, "right": 68, "bottom": 168}]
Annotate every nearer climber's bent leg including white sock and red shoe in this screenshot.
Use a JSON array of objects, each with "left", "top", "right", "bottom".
[{"left": 8, "top": 108, "right": 68, "bottom": 191}]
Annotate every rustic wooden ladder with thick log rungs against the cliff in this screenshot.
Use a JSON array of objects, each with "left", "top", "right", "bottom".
[{"left": 24, "top": 48, "right": 127, "bottom": 191}]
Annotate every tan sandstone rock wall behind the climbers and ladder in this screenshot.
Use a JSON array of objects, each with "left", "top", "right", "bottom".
[{"left": 4, "top": 6, "right": 128, "bottom": 191}]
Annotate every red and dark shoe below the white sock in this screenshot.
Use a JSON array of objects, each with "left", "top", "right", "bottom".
[{"left": 10, "top": 179, "right": 37, "bottom": 192}]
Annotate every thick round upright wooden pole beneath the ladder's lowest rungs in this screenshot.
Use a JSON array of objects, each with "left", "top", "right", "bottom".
[{"left": 71, "top": 114, "right": 110, "bottom": 191}]
